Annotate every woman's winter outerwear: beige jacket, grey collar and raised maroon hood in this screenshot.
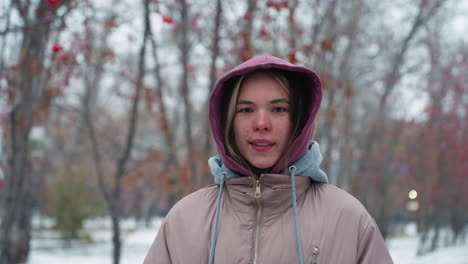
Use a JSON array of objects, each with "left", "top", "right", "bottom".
[{"left": 144, "top": 56, "right": 393, "bottom": 264}]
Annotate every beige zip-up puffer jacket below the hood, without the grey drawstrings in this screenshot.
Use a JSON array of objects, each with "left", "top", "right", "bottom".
[{"left": 144, "top": 174, "right": 393, "bottom": 264}]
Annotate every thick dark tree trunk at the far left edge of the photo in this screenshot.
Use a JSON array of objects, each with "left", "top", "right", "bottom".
[{"left": 0, "top": 1, "right": 69, "bottom": 263}]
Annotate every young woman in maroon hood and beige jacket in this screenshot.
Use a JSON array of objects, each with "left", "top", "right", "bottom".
[{"left": 144, "top": 56, "right": 393, "bottom": 264}]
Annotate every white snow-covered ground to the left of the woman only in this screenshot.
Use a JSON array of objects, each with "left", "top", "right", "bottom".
[{"left": 28, "top": 219, "right": 162, "bottom": 264}]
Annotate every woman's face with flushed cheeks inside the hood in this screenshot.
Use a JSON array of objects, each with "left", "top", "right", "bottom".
[{"left": 233, "top": 73, "right": 291, "bottom": 169}]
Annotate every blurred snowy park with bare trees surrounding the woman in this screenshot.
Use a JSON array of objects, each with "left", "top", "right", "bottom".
[{"left": 0, "top": 0, "right": 468, "bottom": 264}]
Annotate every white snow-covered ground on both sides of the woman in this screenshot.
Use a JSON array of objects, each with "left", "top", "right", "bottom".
[{"left": 28, "top": 219, "right": 468, "bottom": 264}]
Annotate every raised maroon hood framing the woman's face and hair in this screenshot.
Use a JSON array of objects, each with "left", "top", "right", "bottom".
[{"left": 209, "top": 55, "right": 322, "bottom": 175}]
